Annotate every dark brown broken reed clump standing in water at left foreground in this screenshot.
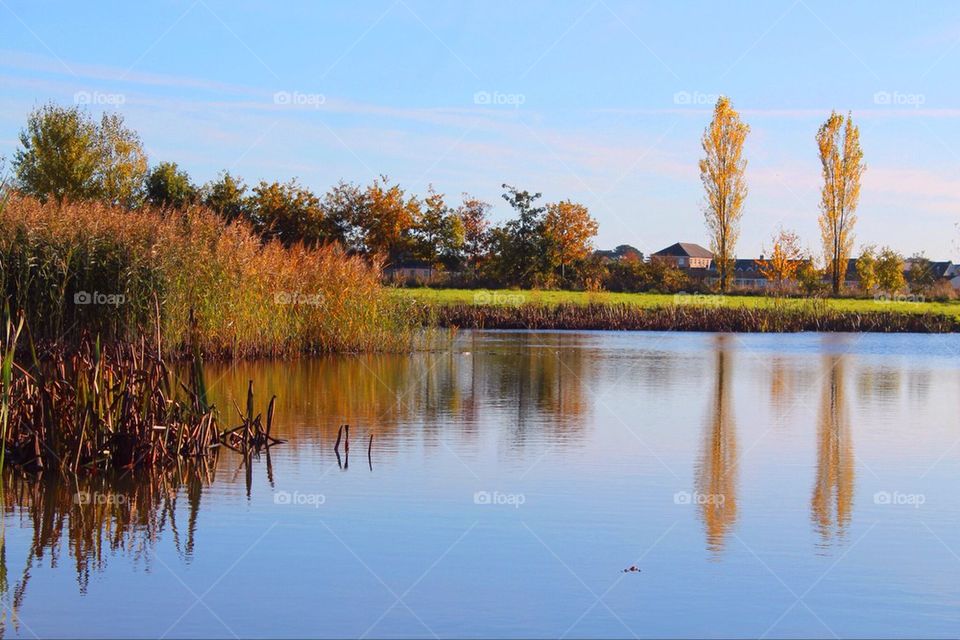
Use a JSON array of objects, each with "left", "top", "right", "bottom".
[{"left": 0, "top": 314, "right": 281, "bottom": 473}]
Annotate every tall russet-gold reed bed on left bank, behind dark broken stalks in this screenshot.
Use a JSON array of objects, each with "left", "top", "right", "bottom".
[{"left": 0, "top": 195, "right": 413, "bottom": 356}]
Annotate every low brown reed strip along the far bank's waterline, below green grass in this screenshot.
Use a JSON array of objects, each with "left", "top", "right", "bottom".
[{"left": 428, "top": 302, "right": 960, "bottom": 333}]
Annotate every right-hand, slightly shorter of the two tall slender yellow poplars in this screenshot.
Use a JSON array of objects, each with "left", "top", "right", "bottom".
[{"left": 817, "top": 112, "right": 866, "bottom": 295}]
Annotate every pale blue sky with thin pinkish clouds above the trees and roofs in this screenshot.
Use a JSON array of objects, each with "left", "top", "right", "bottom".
[{"left": 0, "top": 0, "right": 960, "bottom": 260}]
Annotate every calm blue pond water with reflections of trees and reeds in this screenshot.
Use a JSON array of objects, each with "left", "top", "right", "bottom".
[{"left": 0, "top": 332, "right": 960, "bottom": 638}]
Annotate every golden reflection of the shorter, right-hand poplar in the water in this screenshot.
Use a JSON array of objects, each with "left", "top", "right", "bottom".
[{"left": 811, "top": 356, "right": 854, "bottom": 542}]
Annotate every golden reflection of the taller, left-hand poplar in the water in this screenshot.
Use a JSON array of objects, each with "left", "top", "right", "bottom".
[{"left": 697, "top": 338, "right": 738, "bottom": 552}]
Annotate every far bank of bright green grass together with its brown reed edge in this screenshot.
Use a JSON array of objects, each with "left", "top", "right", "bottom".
[{"left": 402, "top": 289, "right": 960, "bottom": 333}]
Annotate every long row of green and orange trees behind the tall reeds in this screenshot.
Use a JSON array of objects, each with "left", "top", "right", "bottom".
[{"left": 13, "top": 104, "right": 597, "bottom": 286}]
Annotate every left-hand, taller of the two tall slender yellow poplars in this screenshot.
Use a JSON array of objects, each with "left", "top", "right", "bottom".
[{"left": 700, "top": 96, "right": 750, "bottom": 291}]
